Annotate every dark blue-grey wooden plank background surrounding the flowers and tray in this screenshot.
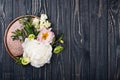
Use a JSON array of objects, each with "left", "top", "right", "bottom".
[{"left": 0, "top": 0, "right": 120, "bottom": 80}]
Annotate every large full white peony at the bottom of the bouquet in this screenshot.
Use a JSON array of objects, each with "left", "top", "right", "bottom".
[{"left": 22, "top": 38, "right": 52, "bottom": 67}]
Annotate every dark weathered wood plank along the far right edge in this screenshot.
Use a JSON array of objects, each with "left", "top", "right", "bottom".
[{"left": 108, "top": 0, "right": 120, "bottom": 80}]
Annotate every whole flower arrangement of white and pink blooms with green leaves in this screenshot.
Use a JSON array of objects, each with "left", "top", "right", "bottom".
[{"left": 11, "top": 14, "right": 64, "bottom": 68}]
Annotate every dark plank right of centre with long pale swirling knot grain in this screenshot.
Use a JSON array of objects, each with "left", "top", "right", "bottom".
[{"left": 70, "top": 0, "right": 90, "bottom": 80}]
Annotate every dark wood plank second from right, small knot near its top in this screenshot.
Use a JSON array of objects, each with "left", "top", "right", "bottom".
[{"left": 89, "top": 0, "right": 108, "bottom": 80}]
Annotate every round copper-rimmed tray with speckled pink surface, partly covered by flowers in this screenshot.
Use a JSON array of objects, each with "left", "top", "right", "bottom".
[{"left": 4, "top": 15, "right": 37, "bottom": 60}]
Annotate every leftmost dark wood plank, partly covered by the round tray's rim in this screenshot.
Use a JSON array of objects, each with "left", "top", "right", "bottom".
[{"left": 0, "top": 0, "right": 14, "bottom": 80}]
